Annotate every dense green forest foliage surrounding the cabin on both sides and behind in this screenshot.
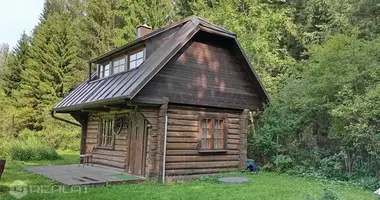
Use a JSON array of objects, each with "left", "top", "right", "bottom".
[{"left": 0, "top": 0, "right": 380, "bottom": 188}]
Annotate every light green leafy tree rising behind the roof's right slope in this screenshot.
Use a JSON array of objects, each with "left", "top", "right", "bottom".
[{"left": 178, "top": 0, "right": 298, "bottom": 95}]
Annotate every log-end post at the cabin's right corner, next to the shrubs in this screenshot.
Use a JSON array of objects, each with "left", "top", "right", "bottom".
[{"left": 239, "top": 109, "right": 249, "bottom": 169}]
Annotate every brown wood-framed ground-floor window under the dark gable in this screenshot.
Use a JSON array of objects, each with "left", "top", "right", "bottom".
[{"left": 199, "top": 116, "right": 226, "bottom": 151}]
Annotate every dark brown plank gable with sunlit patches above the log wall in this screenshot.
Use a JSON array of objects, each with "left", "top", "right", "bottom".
[{"left": 133, "top": 32, "right": 262, "bottom": 110}]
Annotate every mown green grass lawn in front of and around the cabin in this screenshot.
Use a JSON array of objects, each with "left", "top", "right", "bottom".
[{"left": 0, "top": 152, "right": 376, "bottom": 200}]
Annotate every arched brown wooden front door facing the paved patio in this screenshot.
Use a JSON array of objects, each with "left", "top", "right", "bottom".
[{"left": 126, "top": 112, "right": 147, "bottom": 175}]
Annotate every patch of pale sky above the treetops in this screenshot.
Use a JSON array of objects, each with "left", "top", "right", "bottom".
[{"left": 0, "top": 0, "right": 44, "bottom": 48}]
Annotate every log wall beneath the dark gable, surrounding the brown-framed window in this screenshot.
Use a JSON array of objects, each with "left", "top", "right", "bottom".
[{"left": 166, "top": 104, "right": 248, "bottom": 179}]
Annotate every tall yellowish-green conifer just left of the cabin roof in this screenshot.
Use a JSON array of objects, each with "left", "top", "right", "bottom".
[{"left": 16, "top": 13, "right": 84, "bottom": 130}]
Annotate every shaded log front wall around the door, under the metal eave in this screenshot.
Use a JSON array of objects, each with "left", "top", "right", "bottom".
[{"left": 86, "top": 107, "right": 158, "bottom": 177}]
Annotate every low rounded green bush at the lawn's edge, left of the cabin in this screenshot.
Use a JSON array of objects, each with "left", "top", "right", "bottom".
[{"left": 9, "top": 139, "right": 61, "bottom": 161}]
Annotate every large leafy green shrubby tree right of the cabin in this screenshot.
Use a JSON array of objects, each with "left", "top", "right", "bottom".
[{"left": 259, "top": 35, "right": 380, "bottom": 178}]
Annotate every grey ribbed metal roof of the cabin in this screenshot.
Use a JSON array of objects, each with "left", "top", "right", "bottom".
[{"left": 52, "top": 16, "right": 265, "bottom": 112}]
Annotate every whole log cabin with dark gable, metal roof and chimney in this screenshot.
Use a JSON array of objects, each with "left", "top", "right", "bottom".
[{"left": 52, "top": 16, "right": 268, "bottom": 179}]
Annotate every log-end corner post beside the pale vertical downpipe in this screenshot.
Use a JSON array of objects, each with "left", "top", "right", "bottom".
[{"left": 156, "top": 97, "right": 169, "bottom": 182}]
